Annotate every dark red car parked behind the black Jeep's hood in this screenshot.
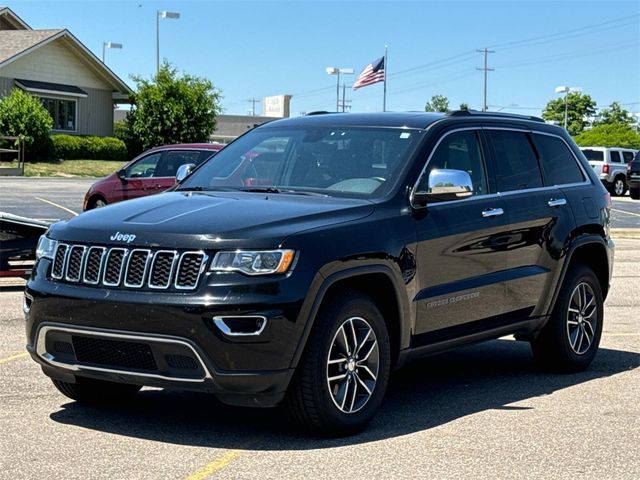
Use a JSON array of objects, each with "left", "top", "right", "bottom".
[{"left": 82, "top": 143, "right": 224, "bottom": 210}]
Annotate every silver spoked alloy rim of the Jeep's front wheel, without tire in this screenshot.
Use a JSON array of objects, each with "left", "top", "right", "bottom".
[{"left": 326, "top": 317, "right": 380, "bottom": 413}]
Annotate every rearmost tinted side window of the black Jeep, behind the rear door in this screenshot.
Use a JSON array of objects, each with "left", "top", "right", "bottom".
[{"left": 533, "top": 134, "right": 584, "bottom": 185}]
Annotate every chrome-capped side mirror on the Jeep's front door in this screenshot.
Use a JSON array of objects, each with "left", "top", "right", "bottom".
[{"left": 411, "top": 168, "right": 473, "bottom": 207}]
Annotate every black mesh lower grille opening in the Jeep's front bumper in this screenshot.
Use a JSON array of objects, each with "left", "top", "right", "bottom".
[{"left": 71, "top": 335, "right": 158, "bottom": 371}]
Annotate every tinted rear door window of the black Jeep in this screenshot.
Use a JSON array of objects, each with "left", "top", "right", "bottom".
[{"left": 488, "top": 130, "right": 542, "bottom": 192}]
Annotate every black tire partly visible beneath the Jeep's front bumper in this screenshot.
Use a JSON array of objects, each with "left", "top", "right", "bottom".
[{"left": 51, "top": 377, "right": 142, "bottom": 404}]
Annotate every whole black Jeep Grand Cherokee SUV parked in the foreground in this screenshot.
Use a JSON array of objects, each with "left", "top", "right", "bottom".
[{"left": 24, "top": 112, "right": 613, "bottom": 434}]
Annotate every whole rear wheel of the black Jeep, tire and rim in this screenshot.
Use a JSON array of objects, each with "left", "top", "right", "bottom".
[{"left": 531, "top": 265, "right": 604, "bottom": 372}]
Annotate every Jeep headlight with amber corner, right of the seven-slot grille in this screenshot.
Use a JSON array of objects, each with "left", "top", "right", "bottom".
[{"left": 211, "top": 250, "right": 295, "bottom": 275}]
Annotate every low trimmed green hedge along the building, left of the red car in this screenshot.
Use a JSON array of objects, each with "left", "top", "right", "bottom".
[{"left": 51, "top": 135, "right": 127, "bottom": 161}]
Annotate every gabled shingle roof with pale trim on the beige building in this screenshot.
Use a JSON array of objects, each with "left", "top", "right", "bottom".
[{"left": 0, "top": 29, "right": 132, "bottom": 95}]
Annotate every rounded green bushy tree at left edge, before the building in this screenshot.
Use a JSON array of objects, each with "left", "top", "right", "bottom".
[{"left": 0, "top": 88, "right": 53, "bottom": 159}]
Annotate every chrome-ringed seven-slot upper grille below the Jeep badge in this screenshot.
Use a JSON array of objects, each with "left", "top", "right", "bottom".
[{"left": 51, "top": 243, "right": 208, "bottom": 290}]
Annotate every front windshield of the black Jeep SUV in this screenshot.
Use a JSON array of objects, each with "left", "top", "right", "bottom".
[{"left": 177, "top": 127, "right": 421, "bottom": 198}]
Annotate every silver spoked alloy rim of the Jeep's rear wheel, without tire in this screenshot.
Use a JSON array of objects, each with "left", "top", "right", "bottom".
[{"left": 567, "top": 282, "right": 598, "bottom": 355}]
